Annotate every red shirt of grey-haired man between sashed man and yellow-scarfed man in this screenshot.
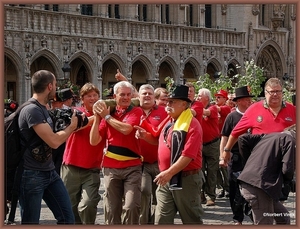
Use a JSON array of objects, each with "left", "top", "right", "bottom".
[{"left": 139, "top": 105, "right": 168, "bottom": 163}]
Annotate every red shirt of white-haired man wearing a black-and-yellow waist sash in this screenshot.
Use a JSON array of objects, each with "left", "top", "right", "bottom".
[{"left": 99, "top": 107, "right": 143, "bottom": 168}]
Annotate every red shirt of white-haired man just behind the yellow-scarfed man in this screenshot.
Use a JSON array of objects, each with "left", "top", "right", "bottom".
[{"left": 202, "top": 106, "right": 220, "bottom": 143}]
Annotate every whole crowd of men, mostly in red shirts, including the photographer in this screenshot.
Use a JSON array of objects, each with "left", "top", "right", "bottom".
[{"left": 5, "top": 70, "right": 296, "bottom": 225}]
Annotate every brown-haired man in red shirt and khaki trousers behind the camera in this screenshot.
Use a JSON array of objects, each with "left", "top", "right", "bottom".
[{"left": 61, "top": 83, "right": 105, "bottom": 224}]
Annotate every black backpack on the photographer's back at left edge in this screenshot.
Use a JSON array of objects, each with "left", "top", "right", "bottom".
[{"left": 4, "top": 100, "right": 37, "bottom": 223}]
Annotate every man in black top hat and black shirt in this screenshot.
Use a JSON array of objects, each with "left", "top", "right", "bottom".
[{"left": 220, "top": 86, "right": 253, "bottom": 225}]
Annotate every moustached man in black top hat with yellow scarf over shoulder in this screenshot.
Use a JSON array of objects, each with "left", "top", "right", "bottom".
[{"left": 150, "top": 85, "right": 204, "bottom": 224}]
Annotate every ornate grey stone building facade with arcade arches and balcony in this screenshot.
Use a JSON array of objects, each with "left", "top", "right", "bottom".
[{"left": 4, "top": 4, "right": 296, "bottom": 103}]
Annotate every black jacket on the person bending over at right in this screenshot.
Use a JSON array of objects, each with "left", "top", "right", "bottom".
[{"left": 238, "top": 132, "right": 296, "bottom": 200}]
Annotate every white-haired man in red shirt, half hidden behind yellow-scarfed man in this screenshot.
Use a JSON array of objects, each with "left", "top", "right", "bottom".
[{"left": 198, "top": 88, "right": 220, "bottom": 206}]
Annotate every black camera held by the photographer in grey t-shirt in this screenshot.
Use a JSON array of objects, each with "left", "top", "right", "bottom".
[{"left": 49, "top": 108, "right": 89, "bottom": 132}]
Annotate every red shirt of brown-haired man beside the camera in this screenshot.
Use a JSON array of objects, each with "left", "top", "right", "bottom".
[{"left": 63, "top": 107, "right": 105, "bottom": 169}]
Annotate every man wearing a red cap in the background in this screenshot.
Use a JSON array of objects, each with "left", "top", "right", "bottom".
[{"left": 215, "top": 89, "right": 231, "bottom": 198}]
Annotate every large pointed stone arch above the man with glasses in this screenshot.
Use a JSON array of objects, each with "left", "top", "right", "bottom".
[{"left": 255, "top": 40, "right": 287, "bottom": 78}]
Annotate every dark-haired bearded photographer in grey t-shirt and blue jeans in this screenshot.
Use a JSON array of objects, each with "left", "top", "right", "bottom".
[{"left": 19, "top": 70, "right": 78, "bottom": 224}]
